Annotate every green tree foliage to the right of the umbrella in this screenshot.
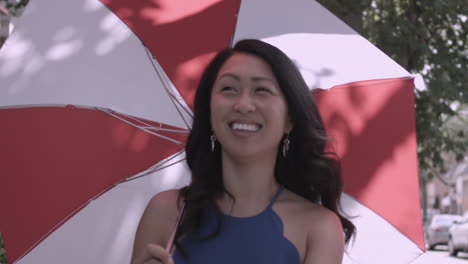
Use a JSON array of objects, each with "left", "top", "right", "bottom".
[{"left": 319, "top": 0, "right": 468, "bottom": 177}]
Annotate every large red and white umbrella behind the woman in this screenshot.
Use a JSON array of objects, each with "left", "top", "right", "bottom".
[{"left": 0, "top": 0, "right": 424, "bottom": 264}]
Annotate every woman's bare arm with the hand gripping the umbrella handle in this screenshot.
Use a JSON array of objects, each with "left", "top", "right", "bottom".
[{"left": 131, "top": 190, "right": 178, "bottom": 264}]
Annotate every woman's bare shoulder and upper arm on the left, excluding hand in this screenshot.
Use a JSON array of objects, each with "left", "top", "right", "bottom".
[{"left": 132, "top": 189, "right": 183, "bottom": 259}]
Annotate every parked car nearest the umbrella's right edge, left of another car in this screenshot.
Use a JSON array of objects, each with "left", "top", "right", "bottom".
[{"left": 426, "top": 214, "right": 461, "bottom": 249}]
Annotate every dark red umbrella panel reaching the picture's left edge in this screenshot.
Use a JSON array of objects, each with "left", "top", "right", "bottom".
[{"left": 0, "top": 106, "right": 187, "bottom": 260}]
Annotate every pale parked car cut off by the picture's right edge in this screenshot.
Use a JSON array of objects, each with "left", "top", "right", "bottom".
[{"left": 448, "top": 212, "right": 468, "bottom": 256}]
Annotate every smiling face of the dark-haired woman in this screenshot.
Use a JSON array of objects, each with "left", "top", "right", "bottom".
[{"left": 210, "top": 53, "right": 292, "bottom": 157}]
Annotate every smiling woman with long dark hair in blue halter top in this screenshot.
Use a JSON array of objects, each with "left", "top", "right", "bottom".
[{"left": 132, "top": 40, "right": 355, "bottom": 264}]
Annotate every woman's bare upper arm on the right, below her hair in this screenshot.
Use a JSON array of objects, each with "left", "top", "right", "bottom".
[{"left": 304, "top": 208, "right": 344, "bottom": 264}]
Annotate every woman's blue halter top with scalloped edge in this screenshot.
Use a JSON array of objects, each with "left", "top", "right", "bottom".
[{"left": 174, "top": 186, "right": 300, "bottom": 264}]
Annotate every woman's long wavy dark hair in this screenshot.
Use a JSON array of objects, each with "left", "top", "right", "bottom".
[{"left": 176, "top": 39, "right": 355, "bottom": 252}]
